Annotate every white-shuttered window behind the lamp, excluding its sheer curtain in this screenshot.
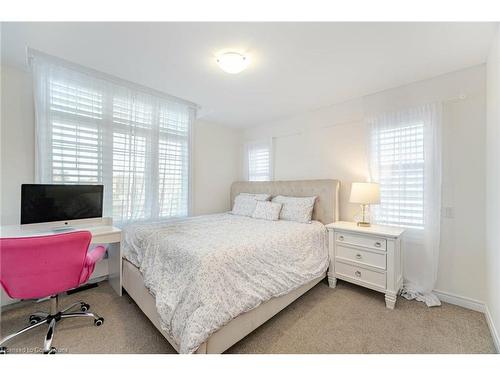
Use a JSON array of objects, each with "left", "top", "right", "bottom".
[{"left": 373, "top": 122, "right": 424, "bottom": 228}]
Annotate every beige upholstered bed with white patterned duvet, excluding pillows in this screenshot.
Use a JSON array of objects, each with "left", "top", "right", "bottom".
[{"left": 123, "top": 180, "right": 340, "bottom": 354}]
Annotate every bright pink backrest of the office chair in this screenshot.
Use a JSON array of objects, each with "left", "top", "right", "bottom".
[{"left": 0, "top": 231, "right": 92, "bottom": 299}]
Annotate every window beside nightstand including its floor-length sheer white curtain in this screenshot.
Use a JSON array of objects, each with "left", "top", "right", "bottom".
[{"left": 369, "top": 103, "right": 443, "bottom": 306}]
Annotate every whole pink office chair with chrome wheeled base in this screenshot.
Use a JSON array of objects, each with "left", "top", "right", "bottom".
[{"left": 0, "top": 231, "right": 106, "bottom": 354}]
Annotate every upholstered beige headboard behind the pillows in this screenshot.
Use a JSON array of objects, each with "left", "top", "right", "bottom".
[{"left": 231, "top": 180, "right": 340, "bottom": 224}]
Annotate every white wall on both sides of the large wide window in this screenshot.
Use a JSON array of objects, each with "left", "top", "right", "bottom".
[{"left": 0, "top": 65, "right": 242, "bottom": 225}]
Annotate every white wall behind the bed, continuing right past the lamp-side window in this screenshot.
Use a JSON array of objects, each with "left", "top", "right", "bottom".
[{"left": 244, "top": 66, "right": 486, "bottom": 301}]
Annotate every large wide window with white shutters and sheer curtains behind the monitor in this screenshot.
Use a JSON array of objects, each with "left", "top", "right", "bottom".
[{"left": 31, "top": 52, "right": 196, "bottom": 223}]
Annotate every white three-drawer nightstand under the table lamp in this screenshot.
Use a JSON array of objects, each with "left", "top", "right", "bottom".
[{"left": 326, "top": 221, "right": 404, "bottom": 309}]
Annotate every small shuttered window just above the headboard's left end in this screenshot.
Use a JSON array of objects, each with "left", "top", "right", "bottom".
[{"left": 246, "top": 141, "right": 273, "bottom": 181}]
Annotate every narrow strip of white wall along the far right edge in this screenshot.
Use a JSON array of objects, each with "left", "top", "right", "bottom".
[{"left": 486, "top": 29, "right": 500, "bottom": 351}]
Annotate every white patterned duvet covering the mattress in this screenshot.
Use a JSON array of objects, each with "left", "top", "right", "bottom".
[{"left": 122, "top": 213, "right": 328, "bottom": 353}]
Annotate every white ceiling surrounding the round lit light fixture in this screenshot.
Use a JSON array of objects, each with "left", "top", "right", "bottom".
[{"left": 2, "top": 23, "right": 495, "bottom": 127}]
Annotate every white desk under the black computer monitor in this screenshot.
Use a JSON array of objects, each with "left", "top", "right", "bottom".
[{"left": 0, "top": 217, "right": 122, "bottom": 302}]
